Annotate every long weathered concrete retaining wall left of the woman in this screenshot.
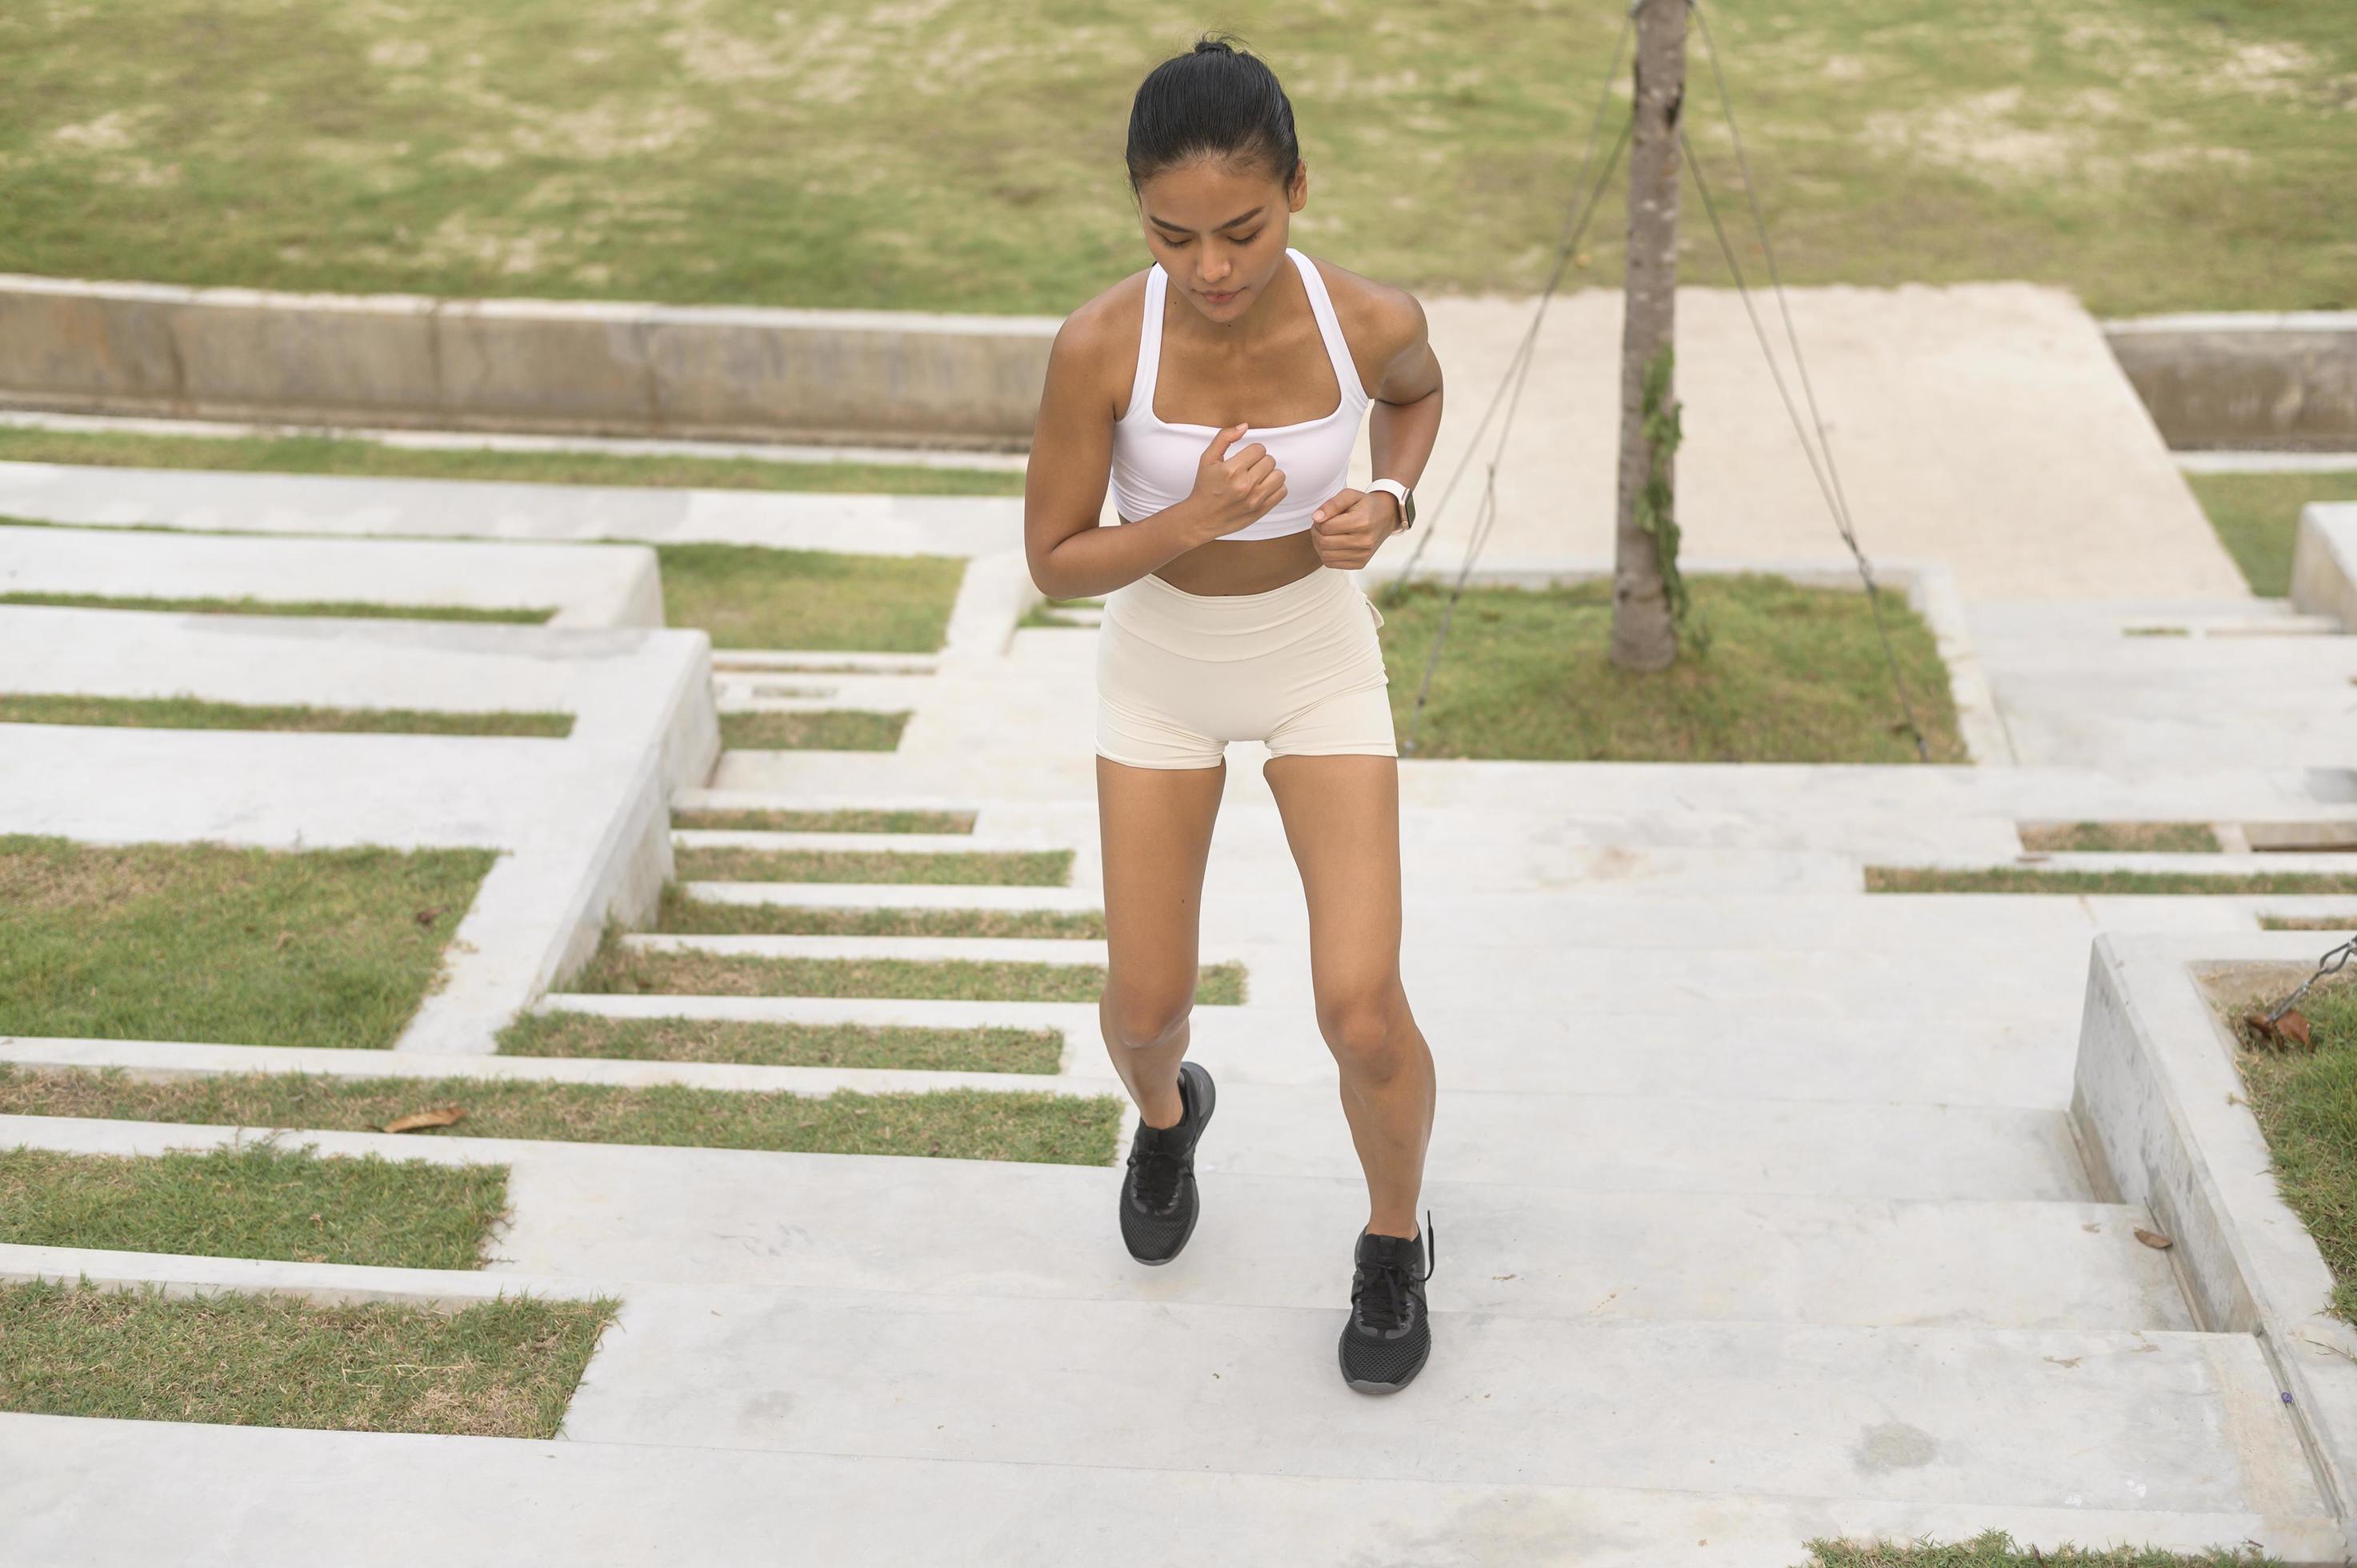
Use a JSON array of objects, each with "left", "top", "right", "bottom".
[{"left": 0, "top": 274, "right": 1058, "bottom": 448}]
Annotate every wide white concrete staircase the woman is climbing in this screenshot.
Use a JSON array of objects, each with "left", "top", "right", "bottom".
[{"left": 478, "top": 604, "right": 2357, "bottom": 1568}]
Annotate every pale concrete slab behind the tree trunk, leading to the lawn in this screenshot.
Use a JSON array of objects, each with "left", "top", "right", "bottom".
[{"left": 1386, "top": 283, "right": 2248, "bottom": 599}]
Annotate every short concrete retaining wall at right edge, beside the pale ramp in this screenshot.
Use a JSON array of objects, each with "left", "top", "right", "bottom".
[{"left": 2103, "top": 311, "right": 2357, "bottom": 453}]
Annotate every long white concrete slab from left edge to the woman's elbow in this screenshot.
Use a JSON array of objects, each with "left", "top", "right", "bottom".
[{"left": 0, "top": 462, "right": 1023, "bottom": 557}]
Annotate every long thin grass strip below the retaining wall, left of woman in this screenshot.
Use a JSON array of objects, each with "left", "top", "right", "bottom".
[{"left": 0, "top": 425, "right": 1023, "bottom": 495}]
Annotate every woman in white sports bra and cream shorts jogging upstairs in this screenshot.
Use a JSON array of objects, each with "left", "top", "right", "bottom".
[{"left": 1023, "top": 38, "right": 1440, "bottom": 1394}]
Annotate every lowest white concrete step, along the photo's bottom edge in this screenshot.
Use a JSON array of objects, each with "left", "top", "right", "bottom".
[{"left": 0, "top": 1410, "right": 2345, "bottom": 1568}]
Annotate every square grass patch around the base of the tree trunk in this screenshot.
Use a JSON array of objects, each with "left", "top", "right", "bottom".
[{"left": 1381, "top": 575, "right": 1966, "bottom": 762}]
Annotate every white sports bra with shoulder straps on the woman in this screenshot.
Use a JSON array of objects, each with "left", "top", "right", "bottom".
[{"left": 1113, "top": 246, "right": 1372, "bottom": 540}]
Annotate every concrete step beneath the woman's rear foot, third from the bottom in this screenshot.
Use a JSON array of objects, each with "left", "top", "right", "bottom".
[{"left": 0, "top": 1122, "right": 2195, "bottom": 1330}]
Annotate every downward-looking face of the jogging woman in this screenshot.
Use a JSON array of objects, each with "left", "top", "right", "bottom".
[{"left": 1138, "top": 158, "right": 1311, "bottom": 321}]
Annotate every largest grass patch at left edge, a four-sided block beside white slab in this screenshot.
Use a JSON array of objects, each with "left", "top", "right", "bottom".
[{"left": 0, "top": 834, "right": 495, "bottom": 1050}]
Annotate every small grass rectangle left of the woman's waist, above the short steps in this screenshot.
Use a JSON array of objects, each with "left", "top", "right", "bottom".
[{"left": 655, "top": 545, "right": 966, "bottom": 650}]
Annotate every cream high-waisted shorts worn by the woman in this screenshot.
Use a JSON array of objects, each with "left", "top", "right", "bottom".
[{"left": 1096, "top": 566, "right": 1400, "bottom": 769}]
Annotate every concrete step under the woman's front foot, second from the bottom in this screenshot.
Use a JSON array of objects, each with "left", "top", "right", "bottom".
[{"left": 566, "top": 1282, "right": 2324, "bottom": 1516}]
